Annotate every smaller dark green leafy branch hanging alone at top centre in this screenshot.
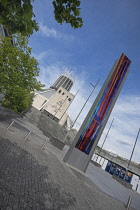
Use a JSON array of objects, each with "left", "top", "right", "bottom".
[{"left": 53, "top": 0, "right": 83, "bottom": 29}]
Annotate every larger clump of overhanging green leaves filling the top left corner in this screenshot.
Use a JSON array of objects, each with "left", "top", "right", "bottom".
[{"left": 0, "top": 0, "right": 39, "bottom": 35}]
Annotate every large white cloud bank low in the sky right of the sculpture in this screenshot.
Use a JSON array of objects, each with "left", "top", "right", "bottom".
[{"left": 100, "top": 95, "right": 140, "bottom": 162}]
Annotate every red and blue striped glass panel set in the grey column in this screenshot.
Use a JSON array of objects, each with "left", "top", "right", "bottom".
[{"left": 75, "top": 54, "right": 131, "bottom": 154}]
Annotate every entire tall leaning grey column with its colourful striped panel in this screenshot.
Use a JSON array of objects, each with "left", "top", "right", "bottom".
[{"left": 64, "top": 54, "right": 131, "bottom": 172}]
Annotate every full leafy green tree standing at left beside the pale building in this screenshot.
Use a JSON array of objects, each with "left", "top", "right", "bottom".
[{"left": 0, "top": 35, "right": 44, "bottom": 113}]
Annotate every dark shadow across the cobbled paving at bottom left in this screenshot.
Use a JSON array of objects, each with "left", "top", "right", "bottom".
[{"left": 0, "top": 138, "right": 76, "bottom": 210}]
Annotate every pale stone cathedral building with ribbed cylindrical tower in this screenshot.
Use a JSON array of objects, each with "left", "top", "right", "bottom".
[{"left": 32, "top": 74, "right": 74, "bottom": 129}]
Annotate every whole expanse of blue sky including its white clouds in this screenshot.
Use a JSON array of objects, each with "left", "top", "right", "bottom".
[{"left": 30, "top": 0, "right": 140, "bottom": 162}]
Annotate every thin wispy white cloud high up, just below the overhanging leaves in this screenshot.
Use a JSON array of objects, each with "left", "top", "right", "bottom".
[{"left": 39, "top": 23, "right": 74, "bottom": 40}]
